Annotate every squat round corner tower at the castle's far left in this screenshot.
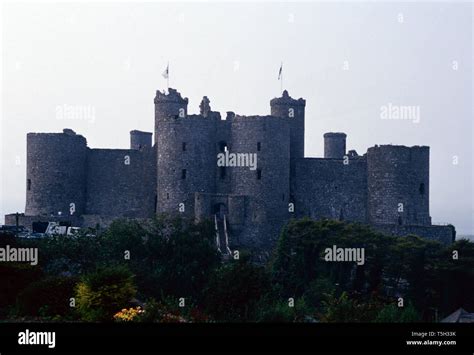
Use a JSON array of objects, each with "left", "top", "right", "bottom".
[{"left": 25, "top": 129, "right": 87, "bottom": 216}]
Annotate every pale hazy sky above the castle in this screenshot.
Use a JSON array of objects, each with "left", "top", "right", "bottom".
[{"left": 0, "top": 2, "right": 474, "bottom": 234}]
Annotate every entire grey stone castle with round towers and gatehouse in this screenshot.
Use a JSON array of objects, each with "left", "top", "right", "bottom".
[{"left": 6, "top": 88, "right": 455, "bottom": 252}]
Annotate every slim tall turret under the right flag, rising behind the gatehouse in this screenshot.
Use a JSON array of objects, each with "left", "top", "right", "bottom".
[{"left": 270, "top": 90, "right": 306, "bottom": 159}]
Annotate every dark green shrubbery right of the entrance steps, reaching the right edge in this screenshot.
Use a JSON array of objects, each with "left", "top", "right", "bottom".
[{"left": 271, "top": 219, "right": 474, "bottom": 321}]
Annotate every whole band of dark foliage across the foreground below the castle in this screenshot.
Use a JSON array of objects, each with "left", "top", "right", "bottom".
[{"left": 0, "top": 216, "right": 474, "bottom": 322}]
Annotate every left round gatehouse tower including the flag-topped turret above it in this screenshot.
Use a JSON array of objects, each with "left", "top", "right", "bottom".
[{"left": 155, "top": 89, "right": 216, "bottom": 217}]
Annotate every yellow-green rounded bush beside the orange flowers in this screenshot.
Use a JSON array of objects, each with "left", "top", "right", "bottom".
[{"left": 76, "top": 266, "right": 136, "bottom": 322}]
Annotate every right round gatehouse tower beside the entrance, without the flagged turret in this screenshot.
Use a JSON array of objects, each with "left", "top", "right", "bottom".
[{"left": 228, "top": 116, "right": 291, "bottom": 248}]
